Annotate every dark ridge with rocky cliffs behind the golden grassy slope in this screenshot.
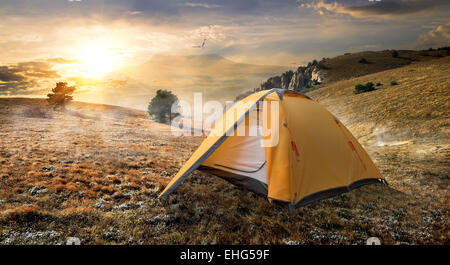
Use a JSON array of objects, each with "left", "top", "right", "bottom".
[{"left": 237, "top": 47, "right": 450, "bottom": 99}]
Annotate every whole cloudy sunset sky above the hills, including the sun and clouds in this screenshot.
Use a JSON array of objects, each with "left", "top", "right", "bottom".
[{"left": 0, "top": 0, "right": 450, "bottom": 106}]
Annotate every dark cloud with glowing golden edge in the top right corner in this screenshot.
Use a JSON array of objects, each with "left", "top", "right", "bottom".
[{"left": 299, "top": 0, "right": 450, "bottom": 18}]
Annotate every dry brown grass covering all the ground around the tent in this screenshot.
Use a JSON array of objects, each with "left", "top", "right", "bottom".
[{"left": 0, "top": 56, "right": 450, "bottom": 244}]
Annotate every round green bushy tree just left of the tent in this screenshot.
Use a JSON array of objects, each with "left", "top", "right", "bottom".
[{"left": 148, "top": 89, "right": 179, "bottom": 123}]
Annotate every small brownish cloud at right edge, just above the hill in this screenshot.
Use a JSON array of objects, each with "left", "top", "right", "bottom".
[{"left": 416, "top": 22, "right": 450, "bottom": 49}]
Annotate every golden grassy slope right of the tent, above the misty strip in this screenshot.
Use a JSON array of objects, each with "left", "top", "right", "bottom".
[{"left": 308, "top": 54, "right": 450, "bottom": 143}]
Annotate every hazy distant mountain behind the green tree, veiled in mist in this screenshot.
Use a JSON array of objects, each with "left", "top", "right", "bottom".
[{"left": 120, "top": 54, "right": 289, "bottom": 104}]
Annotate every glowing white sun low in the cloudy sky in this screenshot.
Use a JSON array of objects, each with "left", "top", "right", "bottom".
[{"left": 77, "top": 47, "right": 117, "bottom": 78}]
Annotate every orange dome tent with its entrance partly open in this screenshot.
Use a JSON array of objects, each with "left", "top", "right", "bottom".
[{"left": 159, "top": 89, "right": 386, "bottom": 209}]
